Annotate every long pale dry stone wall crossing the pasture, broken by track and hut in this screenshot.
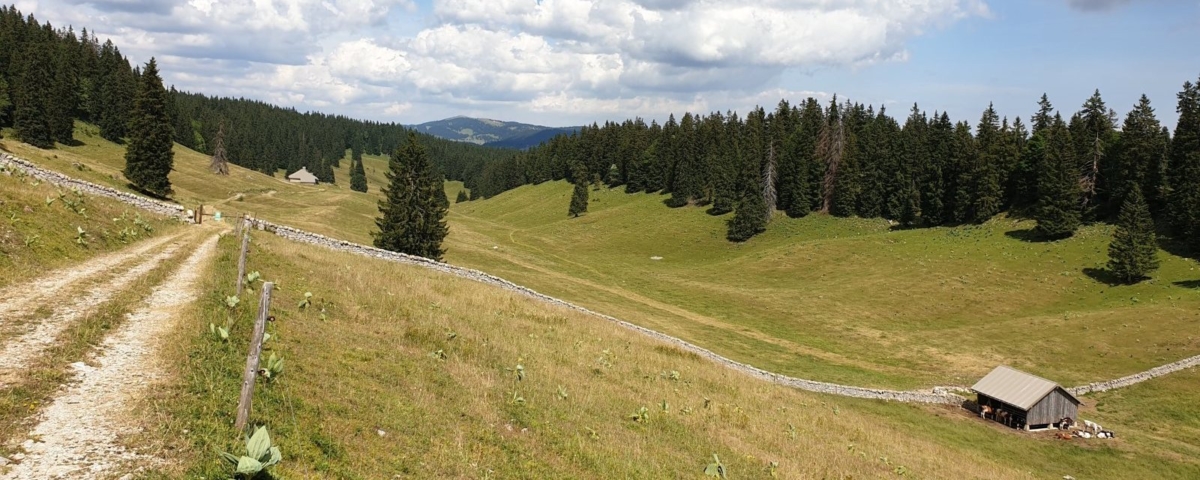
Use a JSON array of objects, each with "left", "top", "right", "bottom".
[{"left": 7, "top": 152, "right": 1200, "bottom": 404}]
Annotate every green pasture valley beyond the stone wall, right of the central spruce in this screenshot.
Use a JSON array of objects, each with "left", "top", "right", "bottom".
[{"left": 446, "top": 182, "right": 1200, "bottom": 388}]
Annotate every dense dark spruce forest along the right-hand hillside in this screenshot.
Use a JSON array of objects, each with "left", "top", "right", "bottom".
[{"left": 472, "top": 83, "right": 1200, "bottom": 247}]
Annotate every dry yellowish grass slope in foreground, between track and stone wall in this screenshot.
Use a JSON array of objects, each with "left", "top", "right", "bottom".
[{"left": 140, "top": 234, "right": 1200, "bottom": 479}]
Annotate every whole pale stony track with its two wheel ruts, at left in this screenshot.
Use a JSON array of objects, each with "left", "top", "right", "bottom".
[{"left": 0, "top": 229, "right": 216, "bottom": 480}]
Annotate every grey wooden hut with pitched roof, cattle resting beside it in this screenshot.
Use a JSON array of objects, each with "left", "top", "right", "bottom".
[{"left": 971, "top": 365, "right": 1081, "bottom": 430}]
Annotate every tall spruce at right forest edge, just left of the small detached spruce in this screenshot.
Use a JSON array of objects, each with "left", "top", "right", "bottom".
[{"left": 1033, "top": 115, "right": 1080, "bottom": 240}]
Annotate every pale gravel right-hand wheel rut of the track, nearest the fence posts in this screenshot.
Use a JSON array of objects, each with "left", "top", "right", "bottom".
[{"left": 0, "top": 235, "right": 217, "bottom": 480}]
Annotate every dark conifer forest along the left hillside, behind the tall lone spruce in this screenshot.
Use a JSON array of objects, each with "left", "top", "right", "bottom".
[{"left": 0, "top": 6, "right": 514, "bottom": 186}]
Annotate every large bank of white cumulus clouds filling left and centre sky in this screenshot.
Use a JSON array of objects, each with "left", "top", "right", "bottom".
[{"left": 23, "top": 0, "right": 988, "bottom": 124}]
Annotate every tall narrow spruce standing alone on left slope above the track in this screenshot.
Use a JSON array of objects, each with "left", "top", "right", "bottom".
[{"left": 124, "top": 58, "right": 175, "bottom": 197}]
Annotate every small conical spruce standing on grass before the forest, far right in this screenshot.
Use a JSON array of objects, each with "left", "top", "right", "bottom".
[{"left": 1109, "top": 184, "right": 1158, "bottom": 283}]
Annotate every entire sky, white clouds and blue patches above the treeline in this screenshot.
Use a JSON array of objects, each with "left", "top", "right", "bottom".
[{"left": 16, "top": 0, "right": 1200, "bottom": 126}]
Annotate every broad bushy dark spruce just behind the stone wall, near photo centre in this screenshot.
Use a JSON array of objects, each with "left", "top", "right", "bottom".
[{"left": 373, "top": 131, "right": 449, "bottom": 260}]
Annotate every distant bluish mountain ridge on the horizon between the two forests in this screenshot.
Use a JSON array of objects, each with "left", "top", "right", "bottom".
[{"left": 410, "top": 116, "right": 580, "bottom": 150}]
